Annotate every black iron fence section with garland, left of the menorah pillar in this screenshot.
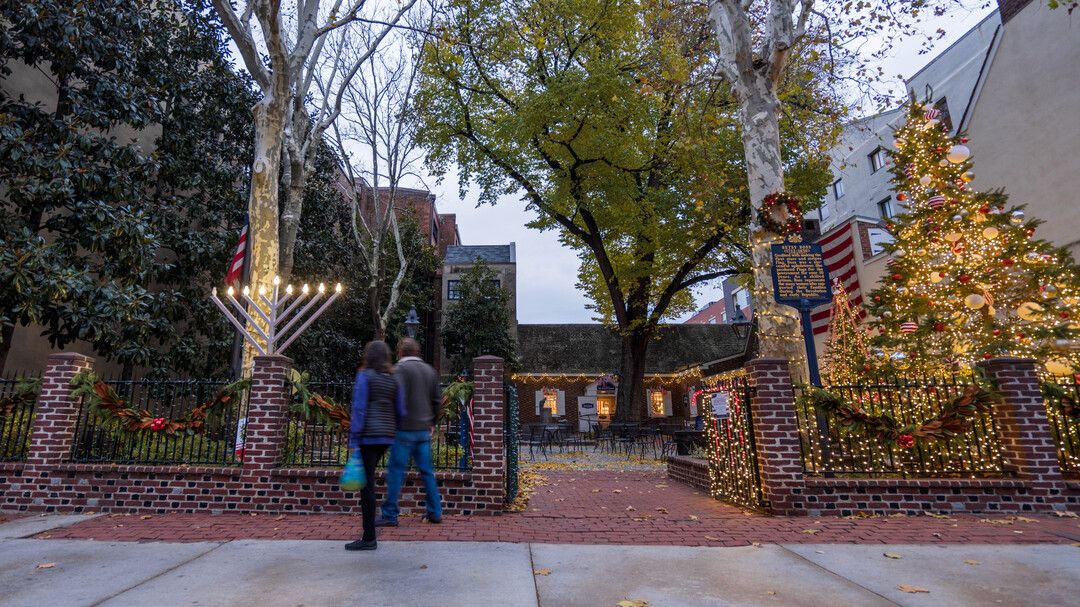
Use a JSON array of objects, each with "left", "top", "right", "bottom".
[{"left": 71, "top": 379, "right": 247, "bottom": 466}]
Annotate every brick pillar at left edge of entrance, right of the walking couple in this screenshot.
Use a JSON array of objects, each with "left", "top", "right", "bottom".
[{"left": 472, "top": 356, "right": 507, "bottom": 514}]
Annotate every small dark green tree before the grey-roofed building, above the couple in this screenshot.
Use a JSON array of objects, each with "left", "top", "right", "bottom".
[{"left": 441, "top": 259, "right": 517, "bottom": 373}]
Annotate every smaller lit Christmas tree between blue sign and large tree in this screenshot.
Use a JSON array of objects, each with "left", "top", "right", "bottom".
[{"left": 823, "top": 280, "right": 870, "bottom": 386}]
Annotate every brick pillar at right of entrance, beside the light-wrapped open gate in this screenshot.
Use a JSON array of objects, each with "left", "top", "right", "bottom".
[{"left": 746, "top": 359, "right": 807, "bottom": 514}]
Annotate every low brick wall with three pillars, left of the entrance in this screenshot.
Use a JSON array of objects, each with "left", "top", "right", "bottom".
[{"left": 0, "top": 353, "right": 505, "bottom": 515}]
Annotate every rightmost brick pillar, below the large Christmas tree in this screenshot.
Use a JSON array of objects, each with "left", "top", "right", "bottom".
[{"left": 978, "top": 358, "right": 1065, "bottom": 503}]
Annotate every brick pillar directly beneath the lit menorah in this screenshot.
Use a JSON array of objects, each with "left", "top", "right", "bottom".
[{"left": 244, "top": 355, "right": 293, "bottom": 472}]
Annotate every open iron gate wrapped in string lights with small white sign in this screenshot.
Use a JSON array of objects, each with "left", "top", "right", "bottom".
[{"left": 699, "top": 378, "right": 767, "bottom": 509}]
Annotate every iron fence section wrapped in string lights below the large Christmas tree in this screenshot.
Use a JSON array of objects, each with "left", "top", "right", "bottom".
[{"left": 795, "top": 377, "right": 1004, "bottom": 477}]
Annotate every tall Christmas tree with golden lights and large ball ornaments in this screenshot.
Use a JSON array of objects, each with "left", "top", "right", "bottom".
[{"left": 868, "top": 102, "right": 1080, "bottom": 375}]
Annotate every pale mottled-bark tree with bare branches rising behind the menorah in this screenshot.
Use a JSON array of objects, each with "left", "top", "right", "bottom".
[{"left": 212, "top": 0, "right": 417, "bottom": 295}]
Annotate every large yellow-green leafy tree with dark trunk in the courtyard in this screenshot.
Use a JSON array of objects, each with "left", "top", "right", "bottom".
[{"left": 418, "top": 0, "right": 829, "bottom": 419}]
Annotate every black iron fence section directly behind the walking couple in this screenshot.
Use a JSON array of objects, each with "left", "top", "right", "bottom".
[{"left": 283, "top": 380, "right": 471, "bottom": 470}]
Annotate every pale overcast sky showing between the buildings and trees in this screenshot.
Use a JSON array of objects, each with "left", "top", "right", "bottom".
[{"left": 429, "top": 2, "right": 996, "bottom": 323}]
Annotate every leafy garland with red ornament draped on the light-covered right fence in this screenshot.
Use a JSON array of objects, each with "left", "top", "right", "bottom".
[{"left": 799, "top": 383, "right": 1001, "bottom": 449}]
